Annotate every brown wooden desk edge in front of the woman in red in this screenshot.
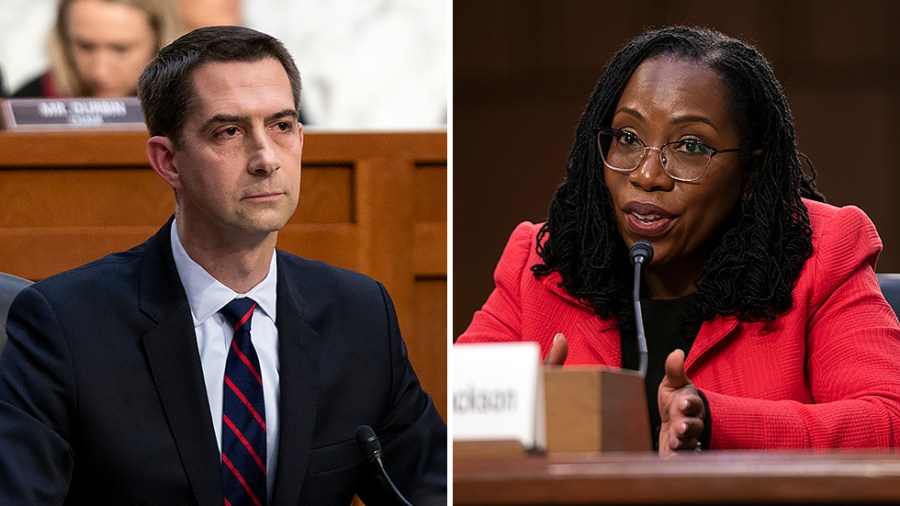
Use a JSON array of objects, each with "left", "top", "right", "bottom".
[{"left": 453, "top": 451, "right": 900, "bottom": 506}]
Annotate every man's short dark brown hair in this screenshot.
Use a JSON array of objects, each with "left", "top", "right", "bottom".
[{"left": 138, "top": 26, "right": 300, "bottom": 146}]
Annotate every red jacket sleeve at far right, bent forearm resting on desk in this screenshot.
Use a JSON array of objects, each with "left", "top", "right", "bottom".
[{"left": 704, "top": 207, "right": 900, "bottom": 449}]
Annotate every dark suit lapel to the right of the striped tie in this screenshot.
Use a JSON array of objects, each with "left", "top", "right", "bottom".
[{"left": 272, "top": 252, "right": 320, "bottom": 505}]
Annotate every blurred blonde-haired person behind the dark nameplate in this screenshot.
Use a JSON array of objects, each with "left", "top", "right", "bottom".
[{"left": 12, "top": 0, "right": 182, "bottom": 98}]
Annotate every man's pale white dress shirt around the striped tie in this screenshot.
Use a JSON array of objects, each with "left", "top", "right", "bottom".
[{"left": 171, "top": 221, "right": 279, "bottom": 497}]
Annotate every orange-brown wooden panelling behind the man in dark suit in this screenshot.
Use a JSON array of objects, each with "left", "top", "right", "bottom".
[{"left": 0, "top": 130, "right": 447, "bottom": 416}]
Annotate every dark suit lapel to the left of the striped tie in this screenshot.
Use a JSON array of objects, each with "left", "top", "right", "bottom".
[{"left": 140, "top": 221, "right": 222, "bottom": 506}]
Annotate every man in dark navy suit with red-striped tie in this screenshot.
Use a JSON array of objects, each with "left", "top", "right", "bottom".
[{"left": 0, "top": 27, "right": 447, "bottom": 505}]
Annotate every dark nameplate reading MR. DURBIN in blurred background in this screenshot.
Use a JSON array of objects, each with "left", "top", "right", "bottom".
[{"left": 0, "top": 97, "right": 147, "bottom": 131}]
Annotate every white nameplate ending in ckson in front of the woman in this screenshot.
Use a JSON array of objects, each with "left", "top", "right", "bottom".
[{"left": 451, "top": 342, "right": 545, "bottom": 450}]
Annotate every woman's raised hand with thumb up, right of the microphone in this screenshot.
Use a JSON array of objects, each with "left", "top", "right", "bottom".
[{"left": 657, "top": 350, "right": 706, "bottom": 455}]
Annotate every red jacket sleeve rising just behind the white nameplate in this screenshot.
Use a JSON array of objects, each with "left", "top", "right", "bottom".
[{"left": 456, "top": 222, "right": 538, "bottom": 343}]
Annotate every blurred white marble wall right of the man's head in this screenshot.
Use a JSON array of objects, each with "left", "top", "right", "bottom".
[{"left": 243, "top": 0, "right": 449, "bottom": 130}]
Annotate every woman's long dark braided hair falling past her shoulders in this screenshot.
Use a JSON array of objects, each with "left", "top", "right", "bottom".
[{"left": 531, "top": 27, "right": 824, "bottom": 331}]
